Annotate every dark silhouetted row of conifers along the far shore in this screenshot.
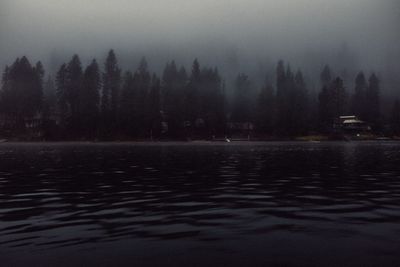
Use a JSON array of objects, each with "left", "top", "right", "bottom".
[{"left": 0, "top": 50, "right": 400, "bottom": 140}]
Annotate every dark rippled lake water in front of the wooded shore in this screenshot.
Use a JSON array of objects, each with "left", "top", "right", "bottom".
[{"left": 0, "top": 142, "right": 400, "bottom": 266}]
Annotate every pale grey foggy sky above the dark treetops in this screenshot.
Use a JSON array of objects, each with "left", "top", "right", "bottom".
[{"left": 0, "top": 0, "right": 400, "bottom": 92}]
